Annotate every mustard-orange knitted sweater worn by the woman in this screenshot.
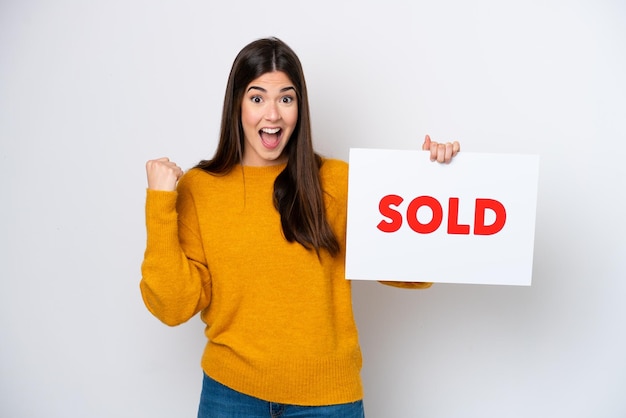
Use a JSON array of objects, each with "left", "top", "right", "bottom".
[{"left": 141, "top": 160, "right": 427, "bottom": 405}]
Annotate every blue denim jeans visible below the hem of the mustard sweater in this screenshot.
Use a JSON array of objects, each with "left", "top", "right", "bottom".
[{"left": 198, "top": 374, "right": 365, "bottom": 418}]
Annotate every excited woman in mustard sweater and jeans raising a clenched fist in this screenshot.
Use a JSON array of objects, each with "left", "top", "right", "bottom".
[{"left": 141, "top": 38, "right": 459, "bottom": 418}]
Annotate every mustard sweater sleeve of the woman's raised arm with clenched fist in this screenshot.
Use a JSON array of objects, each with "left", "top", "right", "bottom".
[{"left": 140, "top": 186, "right": 211, "bottom": 326}]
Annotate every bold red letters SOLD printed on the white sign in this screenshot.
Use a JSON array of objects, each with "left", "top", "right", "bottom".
[{"left": 377, "top": 194, "right": 506, "bottom": 235}]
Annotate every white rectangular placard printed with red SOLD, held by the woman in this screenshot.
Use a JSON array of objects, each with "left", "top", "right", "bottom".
[{"left": 346, "top": 148, "right": 539, "bottom": 286}]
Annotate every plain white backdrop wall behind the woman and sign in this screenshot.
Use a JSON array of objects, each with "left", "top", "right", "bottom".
[{"left": 0, "top": 0, "right": 626, "bottom": 418}]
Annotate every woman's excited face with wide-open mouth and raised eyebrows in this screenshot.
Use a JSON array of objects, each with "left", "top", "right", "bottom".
[{"left": 241, "top": 71, "right": 298, "bottom": 166}]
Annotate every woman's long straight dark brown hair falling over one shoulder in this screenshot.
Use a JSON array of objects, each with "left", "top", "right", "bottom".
[{"left": 196, "top": 38, "right": 339, "bottom": 256}]
